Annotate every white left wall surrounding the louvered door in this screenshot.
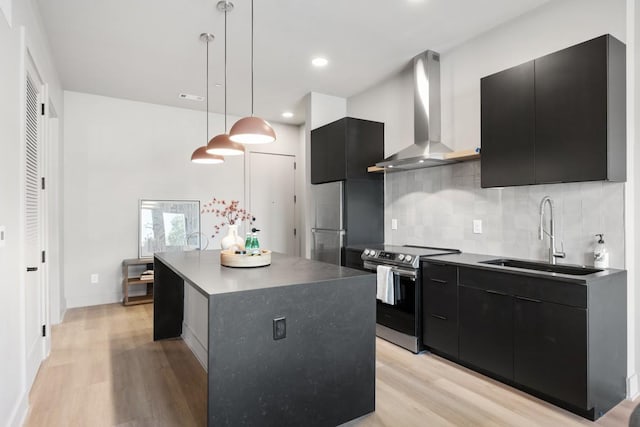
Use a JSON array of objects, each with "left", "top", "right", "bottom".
[{"left": 0, "top": 0, "right": 63, "bottom": 426}]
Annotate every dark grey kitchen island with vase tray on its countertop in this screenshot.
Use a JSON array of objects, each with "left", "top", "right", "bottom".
[{"left": 153, "top": 251, "right": 376, "bottom": 426}]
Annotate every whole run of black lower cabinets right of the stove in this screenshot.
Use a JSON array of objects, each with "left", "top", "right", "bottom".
[{"left": 440, "top": 261, "right": 627, "bottom": 420}]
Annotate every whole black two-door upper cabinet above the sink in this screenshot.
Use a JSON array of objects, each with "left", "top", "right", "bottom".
[{"left": 480, "top": 35, "right": 626, "bottom": 187}]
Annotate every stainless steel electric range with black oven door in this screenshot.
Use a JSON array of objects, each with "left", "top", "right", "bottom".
[{"left": 361, "top": 245, "right": 460, "bottom": 353}]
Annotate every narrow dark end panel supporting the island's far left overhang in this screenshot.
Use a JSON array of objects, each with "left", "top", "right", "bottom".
[{"left": 153, "top": 258, "right": 184, "bottom": 341}]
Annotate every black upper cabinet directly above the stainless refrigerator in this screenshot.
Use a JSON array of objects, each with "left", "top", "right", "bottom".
[{"left": 311, "top": 117, "right": 384, "bottom": 184}]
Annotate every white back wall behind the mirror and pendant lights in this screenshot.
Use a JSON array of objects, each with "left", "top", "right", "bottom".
[{"left": 64, "top": 92, "right": 302, "bottom": 307}]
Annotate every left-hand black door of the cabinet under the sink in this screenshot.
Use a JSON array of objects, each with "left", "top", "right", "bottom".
[{"left": 458, "top": 286, "right": 513, "bottom": 380}]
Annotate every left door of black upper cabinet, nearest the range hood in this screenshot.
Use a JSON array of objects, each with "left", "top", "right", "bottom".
[{"left": 480, "top": 61, "right": 535, "bottom": 187}]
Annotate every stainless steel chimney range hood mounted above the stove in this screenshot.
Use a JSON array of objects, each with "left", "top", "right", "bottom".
[{"left": 376, "top": 50, "right": 479, "bottom": 170}]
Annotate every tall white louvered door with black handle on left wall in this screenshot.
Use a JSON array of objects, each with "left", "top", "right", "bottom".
[{"left": 24, "top": 56, "right": 44, "bottom": 384}]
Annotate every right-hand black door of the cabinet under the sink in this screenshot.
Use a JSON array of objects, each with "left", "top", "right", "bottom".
[{"left": 513, "top": 296, "right": 587, "bottom": 408}]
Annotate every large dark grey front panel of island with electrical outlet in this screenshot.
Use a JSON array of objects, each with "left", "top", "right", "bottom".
[{"left": 207, "top": 275, "right": 376, "bottom": 426}]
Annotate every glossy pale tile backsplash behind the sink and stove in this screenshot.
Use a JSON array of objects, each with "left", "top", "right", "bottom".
[{"left": 385, "top": 161, "right": 624, "bottom": 268}]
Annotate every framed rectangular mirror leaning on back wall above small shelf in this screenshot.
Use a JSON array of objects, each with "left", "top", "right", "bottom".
[{"left": 138, "top": 199, "right": 201, "bottom": 258}]
